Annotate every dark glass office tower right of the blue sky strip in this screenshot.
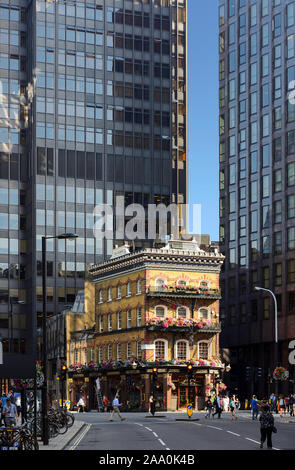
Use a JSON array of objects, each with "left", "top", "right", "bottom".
[{"left": 219, "top": 0, "right": 295, "bottom": 393}]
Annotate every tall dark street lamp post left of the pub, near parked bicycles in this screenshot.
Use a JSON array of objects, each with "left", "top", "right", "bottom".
[{"left": 42, "top": 233, "right": 78, "bottom": 445}]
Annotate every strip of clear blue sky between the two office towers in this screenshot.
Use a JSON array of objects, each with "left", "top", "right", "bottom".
[{"left": 188, "top": 0, "right": 219, "bottom": 240}]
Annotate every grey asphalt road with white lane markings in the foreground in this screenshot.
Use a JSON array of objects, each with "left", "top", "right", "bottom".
[{"left": 66, "top": 412, "right": 295, "bottom": 451}]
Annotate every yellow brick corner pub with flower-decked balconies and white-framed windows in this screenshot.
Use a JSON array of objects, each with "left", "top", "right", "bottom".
[{"left": 69, "top": 240, "right": 224, "bottom": 410}]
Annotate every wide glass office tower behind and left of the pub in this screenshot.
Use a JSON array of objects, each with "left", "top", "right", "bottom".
[{"left": 0, "top": 0, "right": 187, "bottom": 373}]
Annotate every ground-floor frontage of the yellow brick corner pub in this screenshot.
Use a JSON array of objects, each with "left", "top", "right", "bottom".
[{"left": 67, "top": 367, "right": 224, "bottom": 411}]
